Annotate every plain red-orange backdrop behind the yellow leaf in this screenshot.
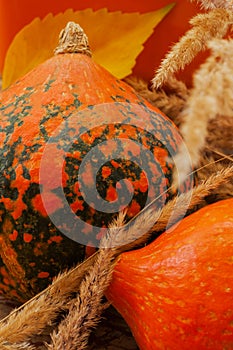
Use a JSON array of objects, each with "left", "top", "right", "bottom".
[{"left": 0, "top": 0, "right": 204, "bottom": 83}]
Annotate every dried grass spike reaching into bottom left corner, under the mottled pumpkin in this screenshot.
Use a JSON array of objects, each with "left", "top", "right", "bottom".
[{"left": 0, "top": 256, "right": 96, "bottom": 348}]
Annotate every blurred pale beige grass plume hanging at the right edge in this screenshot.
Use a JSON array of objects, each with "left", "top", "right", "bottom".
[{"left": 174, "top": 39, "right": 233, "bottom": 181}]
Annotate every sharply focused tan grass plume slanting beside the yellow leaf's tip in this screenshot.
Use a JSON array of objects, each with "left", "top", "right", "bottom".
[{"left": 152, "top": 9, "right": 233, "bottom": 89}]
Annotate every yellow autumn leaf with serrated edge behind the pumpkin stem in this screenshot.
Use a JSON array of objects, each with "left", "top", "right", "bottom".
[{"left": 2, "top": 4, "right": 174, "bottom": 88}]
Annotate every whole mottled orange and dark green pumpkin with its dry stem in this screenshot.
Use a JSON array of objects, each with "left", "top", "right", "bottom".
[{"left": 0, "top": 22, "right": 192, "bottom": 300}]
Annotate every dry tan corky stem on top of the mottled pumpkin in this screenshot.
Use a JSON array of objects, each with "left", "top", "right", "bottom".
[{"left": 54, "top": 22, "right": 91, "bottom": 56}]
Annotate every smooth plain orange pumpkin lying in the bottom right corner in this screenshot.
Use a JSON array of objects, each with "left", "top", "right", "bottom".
[{"left": 106, "top": 198, "right": 233, "bottom": 350}]
